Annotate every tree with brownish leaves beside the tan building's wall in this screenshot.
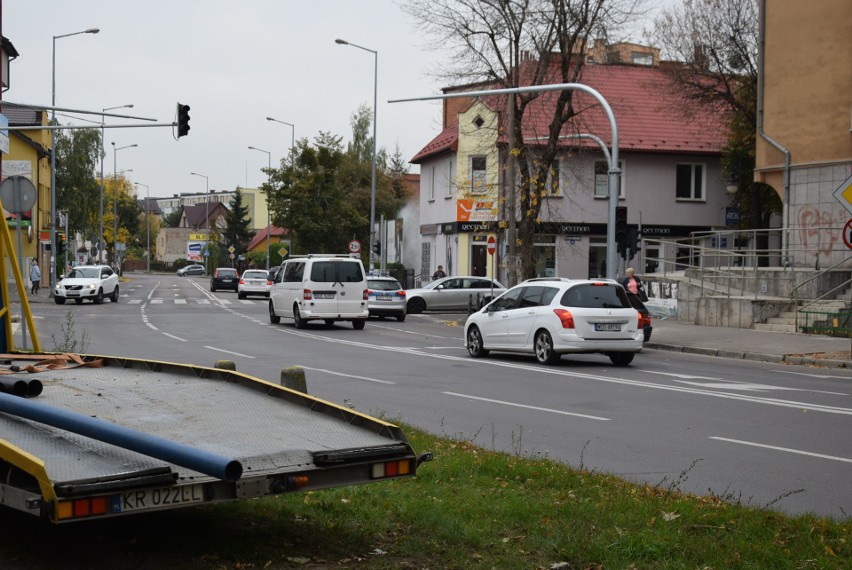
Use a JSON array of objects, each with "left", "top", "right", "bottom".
[{"left": 652, "top": 0, "right": 782, "bottom": 233}]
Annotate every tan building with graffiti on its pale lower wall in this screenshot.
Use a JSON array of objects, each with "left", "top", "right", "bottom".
[{"left": 755, "top": 0, "right": 852, "bottom": 268}]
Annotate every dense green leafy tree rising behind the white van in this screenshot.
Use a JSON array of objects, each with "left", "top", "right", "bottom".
[{"left": 269, "top": 132, "right": 369, "bottom": 253}]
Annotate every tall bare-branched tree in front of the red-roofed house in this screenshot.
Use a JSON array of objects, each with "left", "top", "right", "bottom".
[{"left": 406, "top": 0, "right": 636, "bottom": 282}]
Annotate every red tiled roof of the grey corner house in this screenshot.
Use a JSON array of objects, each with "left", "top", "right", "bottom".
[{"left": 411, "top": 65, "right": 727, "bottom": 162}]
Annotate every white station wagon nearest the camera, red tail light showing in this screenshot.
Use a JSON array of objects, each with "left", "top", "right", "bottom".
[{"left": 464, "top": 278, "right": 644, "bottom": 366}]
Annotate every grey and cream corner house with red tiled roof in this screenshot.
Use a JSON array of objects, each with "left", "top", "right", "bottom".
[{"left": 411, "top": 51, "right": 730, "bottom": 279}]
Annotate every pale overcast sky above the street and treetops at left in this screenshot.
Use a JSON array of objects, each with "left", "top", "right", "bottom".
[{"left": 0, "top": 0, "right": 664, "bottom": 197}]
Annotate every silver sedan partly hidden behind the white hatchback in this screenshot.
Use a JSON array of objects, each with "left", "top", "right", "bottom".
[{"left": 405, "top": 276, "right": 506, "bottom": 315}]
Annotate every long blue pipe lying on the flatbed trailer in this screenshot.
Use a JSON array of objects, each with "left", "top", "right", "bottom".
[{"left": 0, "top": 393, "right": 243, "bottom": 482}]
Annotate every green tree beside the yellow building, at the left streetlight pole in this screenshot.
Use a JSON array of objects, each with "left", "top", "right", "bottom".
[{"left": 56, "top": 129, "right": 100, "bottom": 254}]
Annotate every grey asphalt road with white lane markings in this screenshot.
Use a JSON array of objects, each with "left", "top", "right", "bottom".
[{"left": 34, "top": 274, "right": 852, "bottom": 518}]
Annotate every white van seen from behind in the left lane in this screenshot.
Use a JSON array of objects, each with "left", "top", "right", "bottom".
[{"left": 269, "top": 254, "right": 370, "bottom": 330}]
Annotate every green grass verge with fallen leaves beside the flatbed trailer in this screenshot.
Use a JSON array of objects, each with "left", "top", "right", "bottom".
[{"left": 0, "top": 427, "right": 852, "bottom": 570}]
